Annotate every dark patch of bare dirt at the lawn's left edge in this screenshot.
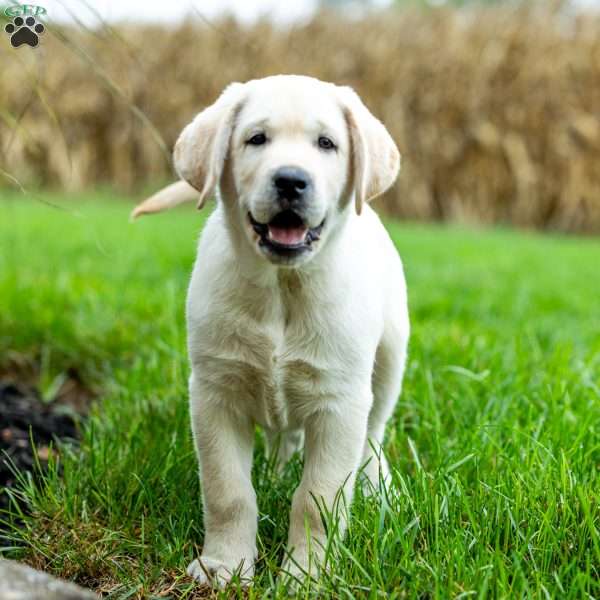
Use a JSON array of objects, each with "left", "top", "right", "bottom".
[{"left": 0, "top": 365, "right": 95, "bottom": 524}]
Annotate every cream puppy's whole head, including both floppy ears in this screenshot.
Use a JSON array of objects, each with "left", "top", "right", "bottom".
[{"left": 137, "top": 75, "right": 400, "bottom": 266}]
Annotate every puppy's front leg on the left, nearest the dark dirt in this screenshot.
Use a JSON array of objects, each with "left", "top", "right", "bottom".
[{"left": 188, "top": 376, "right": 257, "bottom": 587}]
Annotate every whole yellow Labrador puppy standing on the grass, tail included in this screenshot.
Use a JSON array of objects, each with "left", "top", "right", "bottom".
[{"left": 134, "top": 75, "right": 409, "bottom": 585}]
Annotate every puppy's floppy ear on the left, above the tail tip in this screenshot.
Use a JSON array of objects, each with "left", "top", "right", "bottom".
[{"left": 173, "top": 83, "right": 244, "bottom": 208}]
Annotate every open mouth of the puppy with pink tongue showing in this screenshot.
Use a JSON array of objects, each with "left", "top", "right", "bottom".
[{"left": 248, "top": 209, "right": 325, "bottom": 255}]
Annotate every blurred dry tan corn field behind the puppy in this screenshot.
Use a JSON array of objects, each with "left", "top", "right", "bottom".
[{"left": 0, "top": 8, "right": 600, "bottom": 232}]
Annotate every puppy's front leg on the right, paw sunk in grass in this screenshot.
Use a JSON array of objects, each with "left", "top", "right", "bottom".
[{"left": 283, "top": 404, "right": 371, "bottom": 578}]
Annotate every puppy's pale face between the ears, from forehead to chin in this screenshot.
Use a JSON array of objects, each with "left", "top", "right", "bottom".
[{"left": 227, "top": 78, "right": 350, "bottom": 266}]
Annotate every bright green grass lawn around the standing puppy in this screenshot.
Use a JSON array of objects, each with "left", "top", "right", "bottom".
[{"left": 0, "top": 190, "right": 600, "bottom": 598}]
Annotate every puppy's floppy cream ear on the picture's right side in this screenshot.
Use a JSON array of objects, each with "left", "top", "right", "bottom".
[{"left": 338, "top": 87, "right": 400, "bottom": 214}]
